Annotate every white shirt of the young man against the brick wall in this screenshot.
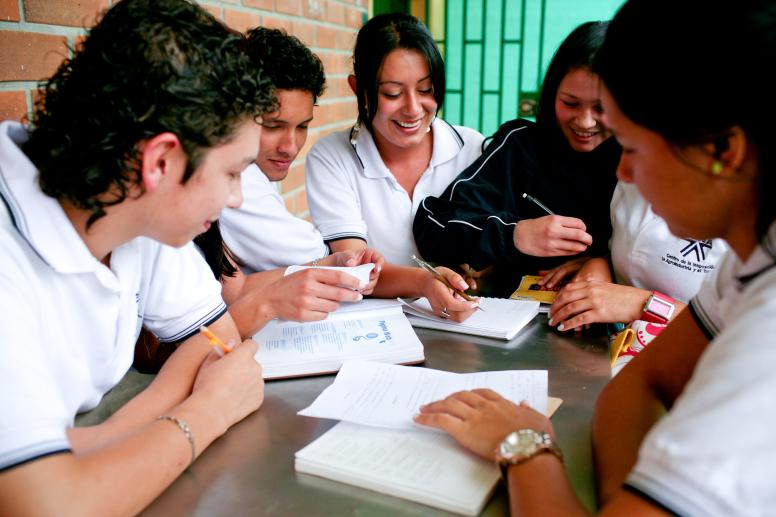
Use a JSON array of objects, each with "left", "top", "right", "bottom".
[{"left": 220, "top": 164, "right": 329, "bottom": 274}]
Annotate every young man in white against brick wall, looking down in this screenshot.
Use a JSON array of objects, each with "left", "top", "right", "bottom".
[{"left": 220, "top": 27, "right": 329, "bottom": 274}]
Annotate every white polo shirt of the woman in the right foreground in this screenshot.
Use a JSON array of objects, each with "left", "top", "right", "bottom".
[{"left": 627, "top": 224, "right": 776, "bottom": 516}]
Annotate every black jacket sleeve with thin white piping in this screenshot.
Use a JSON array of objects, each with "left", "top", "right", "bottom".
[{"left": 413, "top": 120, "right": 532, "bottom": 269}]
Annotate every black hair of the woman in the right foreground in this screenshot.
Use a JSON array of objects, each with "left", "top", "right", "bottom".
[{"left": 594, "top": 0, "right": 776, "bottom": 237}]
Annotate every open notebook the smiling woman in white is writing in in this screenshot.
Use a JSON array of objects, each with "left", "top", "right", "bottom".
[{"left": 402, "top": 297, "right": 539, "bottom": 340}]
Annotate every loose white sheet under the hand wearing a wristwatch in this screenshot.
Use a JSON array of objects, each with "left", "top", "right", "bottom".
[{"left": 298, "top": 361, "right": 547, "bottom": 429}]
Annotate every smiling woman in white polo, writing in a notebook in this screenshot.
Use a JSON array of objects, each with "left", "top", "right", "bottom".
[{"left": 306, "top": 13, "right": 483, "bottom": 320}]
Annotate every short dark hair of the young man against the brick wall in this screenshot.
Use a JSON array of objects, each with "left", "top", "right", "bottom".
[{"left": 247, "top": 27, "right": 326, "bottom": 101}]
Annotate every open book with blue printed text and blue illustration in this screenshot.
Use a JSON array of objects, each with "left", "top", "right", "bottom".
[{"left": 253, "top": 300, "right": 425, "bottom": 379}]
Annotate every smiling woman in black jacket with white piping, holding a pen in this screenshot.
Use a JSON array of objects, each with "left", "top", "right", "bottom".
[{"left": 413, "top": 22, "right": 621, "bottom": 294}]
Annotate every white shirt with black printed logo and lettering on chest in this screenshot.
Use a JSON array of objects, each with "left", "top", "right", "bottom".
[{"left": 611, "top": 182, "right": 728, "bottom": 302}]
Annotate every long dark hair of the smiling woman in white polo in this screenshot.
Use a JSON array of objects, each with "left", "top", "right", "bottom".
[{"left": 353, "top": 13, "right": 445, "bottom": 131}]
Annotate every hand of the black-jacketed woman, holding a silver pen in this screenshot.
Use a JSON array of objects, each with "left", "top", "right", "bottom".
[{"left": 512, "top": 193, "right": 593, "bottom": 257}]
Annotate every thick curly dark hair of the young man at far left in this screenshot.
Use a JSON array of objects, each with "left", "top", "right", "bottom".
[{"left": 23, "top": 0, "right": 275, "bottom": 224}]
